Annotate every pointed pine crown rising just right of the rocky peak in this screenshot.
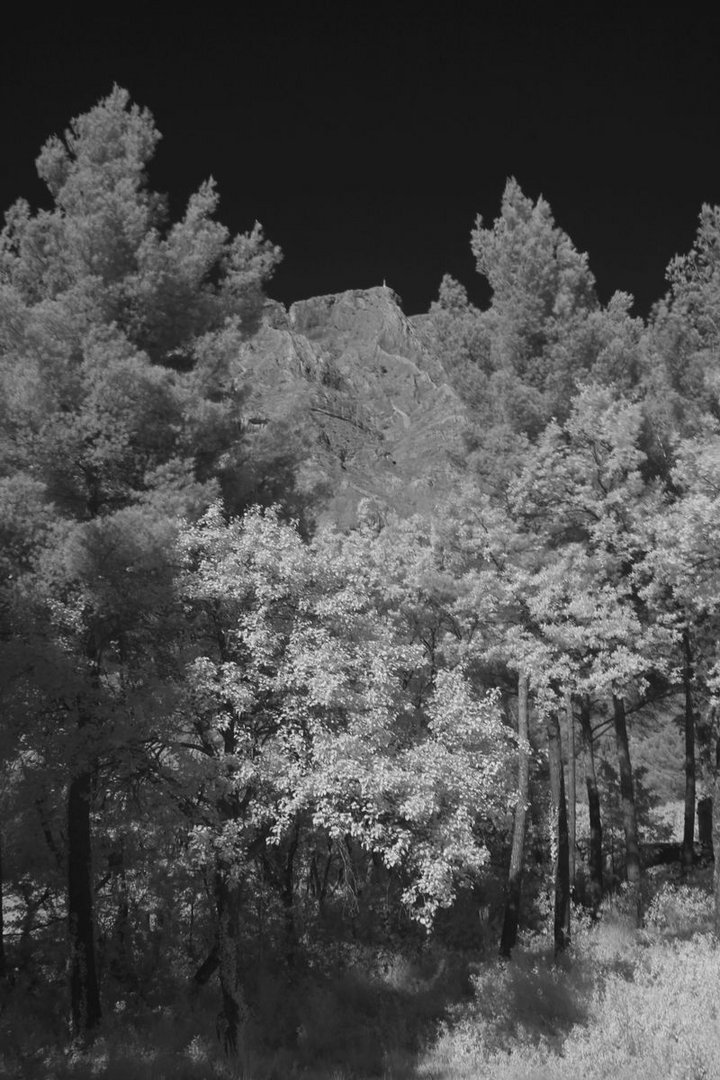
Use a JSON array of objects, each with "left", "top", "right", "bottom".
[{"left": 470, "top": 179, "right": 643, "bottom": 435}]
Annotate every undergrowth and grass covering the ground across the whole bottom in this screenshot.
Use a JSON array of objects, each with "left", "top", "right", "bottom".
[{"left": 0, "top": 872, "right": 720, "bottom": 1080}]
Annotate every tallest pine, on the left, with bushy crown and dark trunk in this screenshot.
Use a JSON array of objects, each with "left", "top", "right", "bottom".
[{"left": 0, "top": 87, "right": 277, "bottom": 1038}]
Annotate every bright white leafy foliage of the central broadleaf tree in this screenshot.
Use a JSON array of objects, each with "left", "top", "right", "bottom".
[{"left": 173, "top": 508, "right": 513, "bottom": 923}]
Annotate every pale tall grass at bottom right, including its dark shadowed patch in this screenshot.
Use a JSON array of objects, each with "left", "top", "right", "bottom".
[{"left": 417, "top": 882, "right": 720, "bottom": 1080}]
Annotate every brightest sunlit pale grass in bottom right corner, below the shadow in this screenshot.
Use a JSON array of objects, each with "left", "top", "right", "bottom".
[{"left": 417, "top": 935, "right": 720, "bottom": 1080}]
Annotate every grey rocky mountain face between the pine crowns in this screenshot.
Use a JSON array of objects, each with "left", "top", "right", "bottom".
[{"left": 240, "top": 286, "right": 466, "bottom": 525}]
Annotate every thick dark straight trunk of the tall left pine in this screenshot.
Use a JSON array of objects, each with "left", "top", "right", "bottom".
[{"left": 68, "top": 770, "right": 101, "bottom": 1041}]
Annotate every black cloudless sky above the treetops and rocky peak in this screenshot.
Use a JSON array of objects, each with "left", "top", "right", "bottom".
[{"left": 0, "top": 2, "right": 720, "bottom": 313}]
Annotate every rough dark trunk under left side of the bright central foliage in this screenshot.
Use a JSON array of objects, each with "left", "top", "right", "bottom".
[{"left": 215, "top": 866, "right": 247, "bottom": 1055}]
